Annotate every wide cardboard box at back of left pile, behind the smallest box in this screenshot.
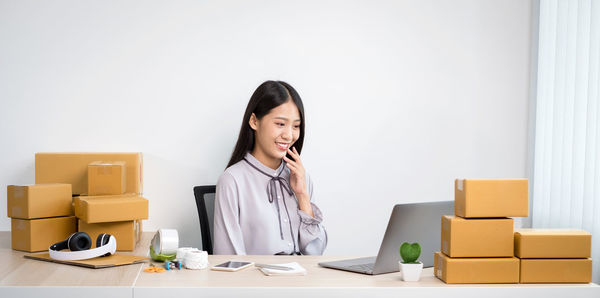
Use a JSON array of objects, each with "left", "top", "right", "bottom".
[{"left": 35, "top": 152, "right": 143, "bottom": 195}]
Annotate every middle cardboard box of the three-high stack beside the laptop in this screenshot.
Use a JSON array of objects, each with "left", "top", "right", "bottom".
[{"left": 441, "top": 215, "right": 514, "bottom": 258}]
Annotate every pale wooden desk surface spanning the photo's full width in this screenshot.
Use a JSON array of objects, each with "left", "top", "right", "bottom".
[{"left": 0, "top": 232, "right": 600, "bottom": 298}]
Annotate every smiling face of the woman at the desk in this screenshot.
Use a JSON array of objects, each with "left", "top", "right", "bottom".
[{"left": 250, "top": 100, "right": 301, "bottom": 169}]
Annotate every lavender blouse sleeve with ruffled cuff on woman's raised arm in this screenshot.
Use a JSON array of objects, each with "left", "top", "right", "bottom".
[{"left": 298, "top": 175, "right": 327, "bottom": 255}]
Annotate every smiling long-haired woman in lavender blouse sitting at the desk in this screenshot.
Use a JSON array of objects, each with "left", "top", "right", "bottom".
[{"left": 214, "top": 81, "right": 327, "bottom": 255}]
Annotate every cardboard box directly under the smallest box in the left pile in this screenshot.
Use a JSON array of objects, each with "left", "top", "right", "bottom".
[{"left": 73, "top": 195, "right": 148, "bottom": 223}]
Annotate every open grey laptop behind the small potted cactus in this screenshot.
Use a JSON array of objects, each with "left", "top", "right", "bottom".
[{"left": 319, "top": 201, "right": 454, "bottom": 275}]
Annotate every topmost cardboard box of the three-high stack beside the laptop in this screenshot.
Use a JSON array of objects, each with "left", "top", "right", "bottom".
[{"left": 454, "top": 179, "right": 529, "bottom": 218}]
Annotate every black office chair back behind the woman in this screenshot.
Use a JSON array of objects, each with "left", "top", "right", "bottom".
[{"left": 194, "top": 185, "right": 216, "bottom": 255}]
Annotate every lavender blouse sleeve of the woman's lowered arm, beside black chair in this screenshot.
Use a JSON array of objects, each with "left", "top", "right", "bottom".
[{"left": 213, "top": 172, "right": 246, "bottom": 255}]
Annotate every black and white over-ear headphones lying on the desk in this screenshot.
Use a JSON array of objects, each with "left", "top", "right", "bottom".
[{"left": 48, "top": 232, "right": 117, "bottom": 261}]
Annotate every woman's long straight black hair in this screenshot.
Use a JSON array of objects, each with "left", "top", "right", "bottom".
[{"left": 227, "top": 81, "right": 304, "bottom": 167}]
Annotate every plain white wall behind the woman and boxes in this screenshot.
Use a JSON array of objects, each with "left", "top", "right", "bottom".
[{"left": 0, "top": 0, "right": 531, "bottom": 255}]
